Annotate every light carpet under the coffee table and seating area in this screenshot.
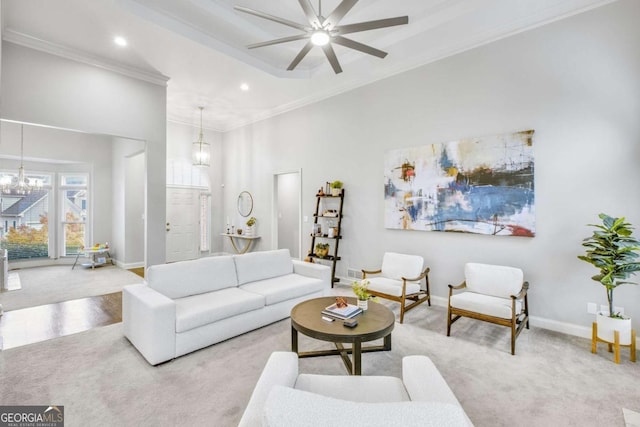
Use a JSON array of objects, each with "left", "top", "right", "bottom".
[{"left": 0, "top": 304, "right": 640, "bottom": 427}]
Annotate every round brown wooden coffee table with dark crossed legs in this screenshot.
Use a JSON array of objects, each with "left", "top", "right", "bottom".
[{"left": 291, "top": 297, "right": 396, "bottom": 375}]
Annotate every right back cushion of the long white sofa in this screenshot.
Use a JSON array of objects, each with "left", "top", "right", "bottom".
[{"left": 233, "top": 249, "right": 293, "bottom": 285}]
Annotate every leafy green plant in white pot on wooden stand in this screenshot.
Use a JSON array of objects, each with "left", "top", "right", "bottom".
[{"left": 578, "top": 213, "right": 640, "bottom": 363}]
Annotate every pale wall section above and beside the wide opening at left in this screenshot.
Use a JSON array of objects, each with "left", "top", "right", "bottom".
[{"left": 0, "top": 42, "right": 166, "bottom": 265}]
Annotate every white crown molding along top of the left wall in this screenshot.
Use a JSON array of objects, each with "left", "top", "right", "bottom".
[{"left": 2, "top": 28, "right": 169, "bottom": 87}]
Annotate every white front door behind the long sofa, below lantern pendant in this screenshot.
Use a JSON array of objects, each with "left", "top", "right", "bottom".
[{"left": 166, "top": 187, "right": 200, "bottom": 262}]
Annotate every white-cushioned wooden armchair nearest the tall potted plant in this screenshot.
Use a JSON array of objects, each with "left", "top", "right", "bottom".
[{"left": 447, "top": 263, "right": 529, "bottom": 354}]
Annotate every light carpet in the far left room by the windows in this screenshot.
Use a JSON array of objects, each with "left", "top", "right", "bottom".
[{"left": 0, "top": 265, "right": 143, "bottom": 311}]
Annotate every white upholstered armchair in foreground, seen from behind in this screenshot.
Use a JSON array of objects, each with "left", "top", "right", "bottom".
[{"left": 239, "top": 351, "right": 473, "bottom": 427}]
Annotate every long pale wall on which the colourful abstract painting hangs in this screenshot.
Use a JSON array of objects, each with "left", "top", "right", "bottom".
[{"left": 223, "top": 0, "right": 640, "bottom": 332}]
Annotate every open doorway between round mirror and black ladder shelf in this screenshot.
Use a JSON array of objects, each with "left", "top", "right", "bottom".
[{"left": 273, "top": 170, "right": 302, "bottom": 259}]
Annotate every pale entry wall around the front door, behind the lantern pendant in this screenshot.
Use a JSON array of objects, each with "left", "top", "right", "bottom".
[{"left": 167, "top": 120, "right": 225, "bottom": 253}]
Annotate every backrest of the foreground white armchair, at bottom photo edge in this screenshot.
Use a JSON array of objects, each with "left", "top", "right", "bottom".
[{"left": 263, "top": 386, "right": 469, "bottom": 427}]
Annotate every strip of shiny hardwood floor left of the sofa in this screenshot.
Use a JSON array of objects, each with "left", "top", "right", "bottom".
[{"left": 0, "top": 292, "right": 122, "bottom": 350}]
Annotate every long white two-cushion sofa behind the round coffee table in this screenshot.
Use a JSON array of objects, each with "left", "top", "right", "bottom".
[{"left": 122, "top": 249, "right": 331, "bottom": 365}]
